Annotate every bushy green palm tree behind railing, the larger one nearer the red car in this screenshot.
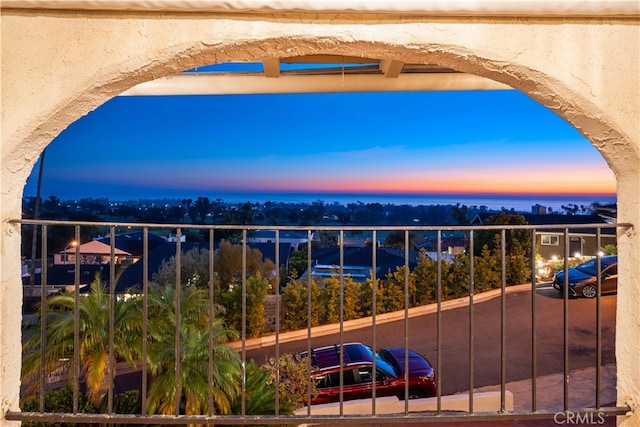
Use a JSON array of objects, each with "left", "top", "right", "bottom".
[{"left": 147, "top": 283, "right": 242, "bottom": 415}]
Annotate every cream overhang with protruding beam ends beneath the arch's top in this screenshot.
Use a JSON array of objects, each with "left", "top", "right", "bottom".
[{"left": 122, "top": 55, "right": 511, "bottom": 96}]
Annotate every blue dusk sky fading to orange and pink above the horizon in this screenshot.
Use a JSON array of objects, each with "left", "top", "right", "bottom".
[{"left": 25, "top": 90, "right": 616, "bottom": 205}]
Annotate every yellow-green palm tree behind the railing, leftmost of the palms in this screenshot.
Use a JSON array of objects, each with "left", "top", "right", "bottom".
[{"left": 22, "top": 275, "right": 142, "bottom": 407}]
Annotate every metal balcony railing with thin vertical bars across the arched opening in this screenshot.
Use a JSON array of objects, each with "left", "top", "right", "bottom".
[{"left": 5, "top": 220, "right": 629, "bottom": 425}]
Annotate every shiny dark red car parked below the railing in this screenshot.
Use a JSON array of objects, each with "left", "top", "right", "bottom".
[{"left": 301, "top": 343, "right": 436, "bottom": 405}]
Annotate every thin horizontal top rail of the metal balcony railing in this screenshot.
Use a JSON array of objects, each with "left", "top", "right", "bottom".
[{"left": 9, "top": 219, "right": 633, "bottom": 231}]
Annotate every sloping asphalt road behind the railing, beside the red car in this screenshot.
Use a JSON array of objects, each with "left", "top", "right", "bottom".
[{"left": 246, "top": 284, "right": 616, "bottom": 395}]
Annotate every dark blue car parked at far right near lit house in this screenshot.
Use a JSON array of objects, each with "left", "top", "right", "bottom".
[{"left": 553, "top": 255, "right": 618, "bottom": 298}]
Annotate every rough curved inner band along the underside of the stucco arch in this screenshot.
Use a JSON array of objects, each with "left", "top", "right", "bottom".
[{"left": 7, "top": 36, "right": 640, "bottom": 185}]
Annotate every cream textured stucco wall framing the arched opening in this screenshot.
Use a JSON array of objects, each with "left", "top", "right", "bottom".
[{"left": 0, "top": 9, "right": 640, "bottom": 425}]
